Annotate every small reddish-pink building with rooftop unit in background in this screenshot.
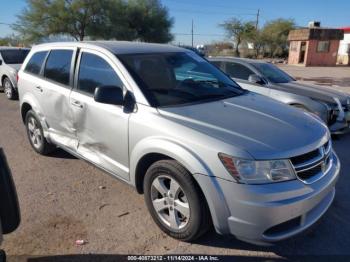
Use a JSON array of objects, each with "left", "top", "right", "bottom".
[{"left": 288, "top": 22, "right": 344, "bottom": 66}]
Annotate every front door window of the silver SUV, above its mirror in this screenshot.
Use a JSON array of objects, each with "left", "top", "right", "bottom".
[{"left": 78, "top": 53, "right": 122, "bottom": 94}]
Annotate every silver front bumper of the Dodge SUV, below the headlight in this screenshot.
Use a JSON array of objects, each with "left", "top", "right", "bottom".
[{"left": 194, "top": 153, "right": 340, "bottom": 245}]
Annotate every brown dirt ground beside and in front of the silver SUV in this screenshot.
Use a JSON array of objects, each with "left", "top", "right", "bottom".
[{"left": 0, "top": 66, "right": 350, "bottom": 261}]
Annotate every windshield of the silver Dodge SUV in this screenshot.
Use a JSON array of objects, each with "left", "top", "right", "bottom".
[{"left": 118, "top": 52, "right": 245, "bottom": 107}]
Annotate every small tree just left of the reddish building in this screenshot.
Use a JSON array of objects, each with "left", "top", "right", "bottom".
[{"left": 260, "top": 18, "right": 295, "bottom": 57}]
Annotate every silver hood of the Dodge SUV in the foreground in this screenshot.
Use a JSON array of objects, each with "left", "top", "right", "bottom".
[{"left": 159, "top": 92, "right": 329, "bottom": 160}]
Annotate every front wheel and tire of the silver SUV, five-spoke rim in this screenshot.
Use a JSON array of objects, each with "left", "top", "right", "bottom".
[{"left": 144, "top": 160, "right": 211, "bottom": 241}]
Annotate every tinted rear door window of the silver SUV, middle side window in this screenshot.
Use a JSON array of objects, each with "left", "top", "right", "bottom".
[{"left": 44, "top": 50, "right": 73, "bottom": 85}]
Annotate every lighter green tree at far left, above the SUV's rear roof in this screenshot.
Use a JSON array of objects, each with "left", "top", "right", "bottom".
[{"left": 13, "top": 0, "right": 107, "bottom": 41}]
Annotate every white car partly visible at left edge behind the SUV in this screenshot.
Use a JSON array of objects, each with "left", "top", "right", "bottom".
[{"left": 0, "top": 47, "right": 30, "bottom": 100}]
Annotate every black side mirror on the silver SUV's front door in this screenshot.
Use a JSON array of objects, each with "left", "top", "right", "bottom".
[{"left": 94, "top": 86, "right": 124, "bottom": 105}]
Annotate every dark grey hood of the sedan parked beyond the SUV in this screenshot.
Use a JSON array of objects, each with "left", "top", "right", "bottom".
[{"left": 271, "top": 81, "right": 349, "bottom": 105}]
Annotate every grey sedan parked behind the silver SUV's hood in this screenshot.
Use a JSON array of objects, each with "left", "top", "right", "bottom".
[{"left": 210, "top": 57, "right": 350, "bottom": 134}]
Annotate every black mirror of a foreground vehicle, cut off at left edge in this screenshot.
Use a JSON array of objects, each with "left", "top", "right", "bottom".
[{"left": 0, "top": 148, "right": 21, "bottom": 234}]
